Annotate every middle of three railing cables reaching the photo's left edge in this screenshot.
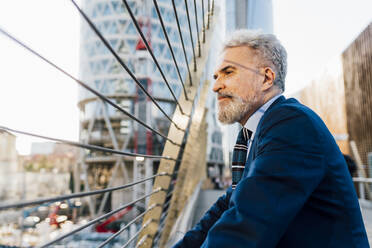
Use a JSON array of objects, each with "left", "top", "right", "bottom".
[{"left": 0, "top": 126, "right": 177, "bottom": 161}]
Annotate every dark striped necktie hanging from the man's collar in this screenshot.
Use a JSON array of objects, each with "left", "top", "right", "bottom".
[{"left": 231, "top": 127, "right": 252, "bottom": 189}]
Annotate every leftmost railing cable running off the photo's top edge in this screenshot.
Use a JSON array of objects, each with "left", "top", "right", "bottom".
[{"left": 71, "top": 0, "right": 184, "bottom": 131}]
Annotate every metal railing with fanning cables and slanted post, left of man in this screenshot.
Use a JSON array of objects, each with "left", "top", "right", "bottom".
[{"left": 0, "top": 0, "right": 214, "bottom": 247}]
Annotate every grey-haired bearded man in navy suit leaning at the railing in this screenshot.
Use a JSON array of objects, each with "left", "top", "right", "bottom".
[{"left": 175, "top": 30, "right": 369, "bottom": 248}]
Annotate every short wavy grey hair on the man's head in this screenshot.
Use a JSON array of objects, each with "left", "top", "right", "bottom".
[{"left": 223, "top": 29, "right": 287, "bottom": 91}]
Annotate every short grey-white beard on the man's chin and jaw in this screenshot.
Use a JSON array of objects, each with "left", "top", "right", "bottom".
[{"left": 218, "top": 96, "right": 254, "bottom": 124}]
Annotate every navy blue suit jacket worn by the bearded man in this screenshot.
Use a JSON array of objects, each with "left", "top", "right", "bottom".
[{"left": 175, "top": 96, "right": 369, "bottom": 248}]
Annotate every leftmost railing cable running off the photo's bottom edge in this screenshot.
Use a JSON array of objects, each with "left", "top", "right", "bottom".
[{"left": 41, "top": 188, "right": 162, "bottom": 248}]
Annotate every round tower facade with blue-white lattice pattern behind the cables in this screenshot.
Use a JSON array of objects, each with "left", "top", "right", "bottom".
[{"left": 75, "top": 0, "right": 222, "bottom": 212}]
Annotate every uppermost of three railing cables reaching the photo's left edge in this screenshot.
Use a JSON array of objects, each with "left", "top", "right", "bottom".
[{"left": 0, "top": 28, "right": 180, "bottom": 146}]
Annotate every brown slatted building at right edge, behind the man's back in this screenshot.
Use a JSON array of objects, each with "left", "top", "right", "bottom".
[{"left": 297, "top": 22, "right": 372, "bottom": 167}]
